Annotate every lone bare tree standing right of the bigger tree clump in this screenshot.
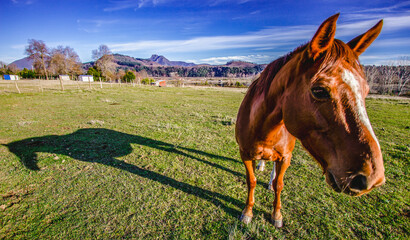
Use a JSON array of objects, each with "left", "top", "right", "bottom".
[{"left": 92, "top": 45, "right": 115, "bottom": 78}]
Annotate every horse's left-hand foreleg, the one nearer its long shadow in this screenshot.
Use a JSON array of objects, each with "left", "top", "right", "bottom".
[{"left": 241, "top": 160, "right": 256, "bottom": 224}]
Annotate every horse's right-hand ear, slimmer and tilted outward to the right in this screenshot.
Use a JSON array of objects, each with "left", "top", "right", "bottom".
[{"left": 347, "top": 20, "right": 383, "bottom": 55}]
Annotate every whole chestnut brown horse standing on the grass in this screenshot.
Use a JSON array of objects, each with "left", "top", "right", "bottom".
[{"left": 236, "top": 14, "right": 385, "bottom": 227}]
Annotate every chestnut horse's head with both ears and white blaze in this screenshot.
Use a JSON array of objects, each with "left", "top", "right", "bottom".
[{"left": 282, "top": 14, "right": 385, "bottom": 196}]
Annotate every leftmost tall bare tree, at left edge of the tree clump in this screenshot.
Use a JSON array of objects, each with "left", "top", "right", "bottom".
[{"left": 25, "top": 39, "right": 50, "bottom": 80}]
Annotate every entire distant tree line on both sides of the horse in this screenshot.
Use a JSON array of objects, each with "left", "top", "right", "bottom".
[{"left": 0, "top": 39, "right": 410, "bottom": 95}]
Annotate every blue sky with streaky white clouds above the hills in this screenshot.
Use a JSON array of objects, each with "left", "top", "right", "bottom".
[{"left": 0, "top": 0, "right": 410, "bottom": 65}]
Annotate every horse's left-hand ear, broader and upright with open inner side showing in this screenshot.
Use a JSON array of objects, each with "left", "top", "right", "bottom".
[{"left": 309, "top": 13, "right": 340, "bottom": 59}]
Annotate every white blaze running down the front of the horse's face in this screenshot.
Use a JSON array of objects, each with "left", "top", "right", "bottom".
[{"left": 342, "top": 70, "right": 380, "bottom": 148}]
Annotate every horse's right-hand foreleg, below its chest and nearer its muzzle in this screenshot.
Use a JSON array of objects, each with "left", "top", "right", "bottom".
[{"left": 272, "top": 156, "right": 290, "bottom": 228}]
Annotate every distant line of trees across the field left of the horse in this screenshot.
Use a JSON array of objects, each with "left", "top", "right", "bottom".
[{"left": 0, "top": 39, "right": 265, "bottom": 81}]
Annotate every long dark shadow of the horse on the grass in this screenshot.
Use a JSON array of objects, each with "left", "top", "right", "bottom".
[{"left": 5, "top": 128, "right": 244, "bottom": 217}]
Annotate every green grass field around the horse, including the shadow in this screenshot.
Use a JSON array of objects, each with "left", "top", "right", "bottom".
[{"left": 0, "top": 84, "right": 410, "bottom": 239}]
